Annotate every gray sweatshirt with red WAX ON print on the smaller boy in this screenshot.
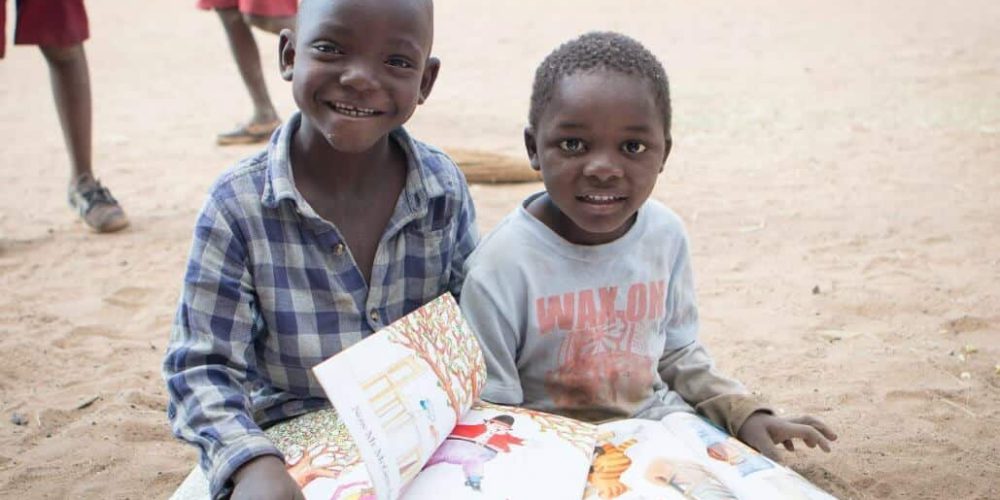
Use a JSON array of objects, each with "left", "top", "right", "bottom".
[{"left": 461, "top": 195, "right": 768, "bottom": 435}]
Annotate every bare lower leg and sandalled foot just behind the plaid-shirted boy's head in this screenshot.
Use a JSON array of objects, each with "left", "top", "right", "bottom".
[{"left": 216, "top": 8, "right": 278, "bottom": 144}]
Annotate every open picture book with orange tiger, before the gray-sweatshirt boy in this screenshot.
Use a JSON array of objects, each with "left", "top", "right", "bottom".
[{"left": 585, "top": 412, "right": 834, "bottom": 500}]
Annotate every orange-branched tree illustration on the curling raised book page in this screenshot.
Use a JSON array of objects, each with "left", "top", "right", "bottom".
[{"left": 389, "top": 296, "right": 486, "bottom": 420}]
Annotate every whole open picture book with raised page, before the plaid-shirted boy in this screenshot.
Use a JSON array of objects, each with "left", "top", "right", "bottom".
[{"left": 280, "top": 294, "right": 596, "bottom": 500}]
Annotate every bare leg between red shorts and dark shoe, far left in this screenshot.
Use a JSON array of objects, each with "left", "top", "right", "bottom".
[{"left": 39, "top": 43, "right": 93, "bottom": 185}]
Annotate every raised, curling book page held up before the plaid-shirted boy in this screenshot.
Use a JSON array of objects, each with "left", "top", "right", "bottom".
[{"left": 313, "top": 294, "right": 486, "bottom": 499}]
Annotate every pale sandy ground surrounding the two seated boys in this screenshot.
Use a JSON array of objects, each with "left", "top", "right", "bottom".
[{"left": 0, "top": 0, "right": 1000, "bottom": 498}]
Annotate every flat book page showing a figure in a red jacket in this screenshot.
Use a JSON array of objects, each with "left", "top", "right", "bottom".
[{"left": 403, "top": 403, "right": 596, "bottom": 500}]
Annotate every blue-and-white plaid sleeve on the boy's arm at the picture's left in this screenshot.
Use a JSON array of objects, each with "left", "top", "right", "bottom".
[{"left": 163, "top": 197, "right": 281, "bottom": 498}]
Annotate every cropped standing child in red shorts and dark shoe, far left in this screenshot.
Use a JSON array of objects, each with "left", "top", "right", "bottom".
[{"left": 0, "top": 0, "right": 128, "bottom": 233}]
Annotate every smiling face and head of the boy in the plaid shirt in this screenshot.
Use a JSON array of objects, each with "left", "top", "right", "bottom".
[{"left": 280, "top": 0, "right": 439, "bottom": 153}]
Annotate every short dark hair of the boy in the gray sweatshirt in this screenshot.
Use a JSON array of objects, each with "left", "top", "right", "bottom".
[{"left": 528, "top": 31, "right": 672, "bottom": 140}]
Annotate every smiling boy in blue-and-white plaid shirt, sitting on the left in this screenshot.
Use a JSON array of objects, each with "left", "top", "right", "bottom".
[{"left": 164, "top": 0, "right": 477, "bottom": 498}]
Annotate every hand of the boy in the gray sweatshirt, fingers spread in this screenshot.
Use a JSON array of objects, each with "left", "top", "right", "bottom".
[{"left": 736, "top": 413, "right": 837, "bottom": 461}]
